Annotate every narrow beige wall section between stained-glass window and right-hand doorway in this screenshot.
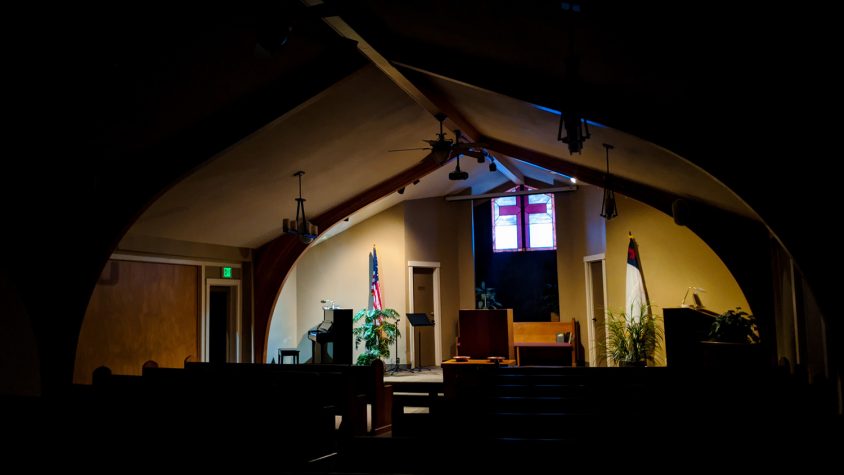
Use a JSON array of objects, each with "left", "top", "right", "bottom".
[{"left": 554, "top": 185, "right": 606, "bottom": 359}]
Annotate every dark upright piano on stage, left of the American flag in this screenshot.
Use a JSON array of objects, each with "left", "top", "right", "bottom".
[{"left": 308, "top": 308, "right": 353, "bottom": 364}]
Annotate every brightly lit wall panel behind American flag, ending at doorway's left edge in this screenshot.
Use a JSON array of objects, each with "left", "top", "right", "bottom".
[{"left": 292, "top": 203, "right": 407, "bottom": 363}]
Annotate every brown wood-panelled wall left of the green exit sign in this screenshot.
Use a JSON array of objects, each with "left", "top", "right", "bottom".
[{"left": 73, "top": 260, "right": 199, "bottom": 384}]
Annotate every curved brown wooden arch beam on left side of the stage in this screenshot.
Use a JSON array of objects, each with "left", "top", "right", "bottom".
[{"left": 254, "top": 155, "right": 442, "bottom": 361}]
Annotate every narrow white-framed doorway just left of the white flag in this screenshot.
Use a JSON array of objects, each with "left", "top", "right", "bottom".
[{"left": 583, "top": 254, "right": 607, "bottom": 366}]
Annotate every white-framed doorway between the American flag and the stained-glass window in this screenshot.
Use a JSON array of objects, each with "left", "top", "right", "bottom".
[{"left": 405, "top": 261, "right": 442, "bottom": 368}]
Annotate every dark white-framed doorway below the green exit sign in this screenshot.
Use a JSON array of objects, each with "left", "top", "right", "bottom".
[{"left": 203, "top": 279, "right": 241, "bottom": 363}]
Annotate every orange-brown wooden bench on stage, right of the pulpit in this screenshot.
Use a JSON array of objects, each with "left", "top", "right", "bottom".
[{"left": 513, "top": 321, "right": 577, "bottom": 366}]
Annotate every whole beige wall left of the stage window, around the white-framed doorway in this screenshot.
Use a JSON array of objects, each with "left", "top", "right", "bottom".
[{"left": 268, "top": 198, "right": 474, "bottom": 364}]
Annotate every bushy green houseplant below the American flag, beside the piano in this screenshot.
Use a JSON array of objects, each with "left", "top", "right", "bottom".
[{"left": 352, "top": 308, "right": 401, "bottom": 366}]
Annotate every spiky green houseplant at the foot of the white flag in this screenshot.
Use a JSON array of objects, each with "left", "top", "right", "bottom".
[{"left": 603, "top": 305, "right": 663, "bottom": 366}]
